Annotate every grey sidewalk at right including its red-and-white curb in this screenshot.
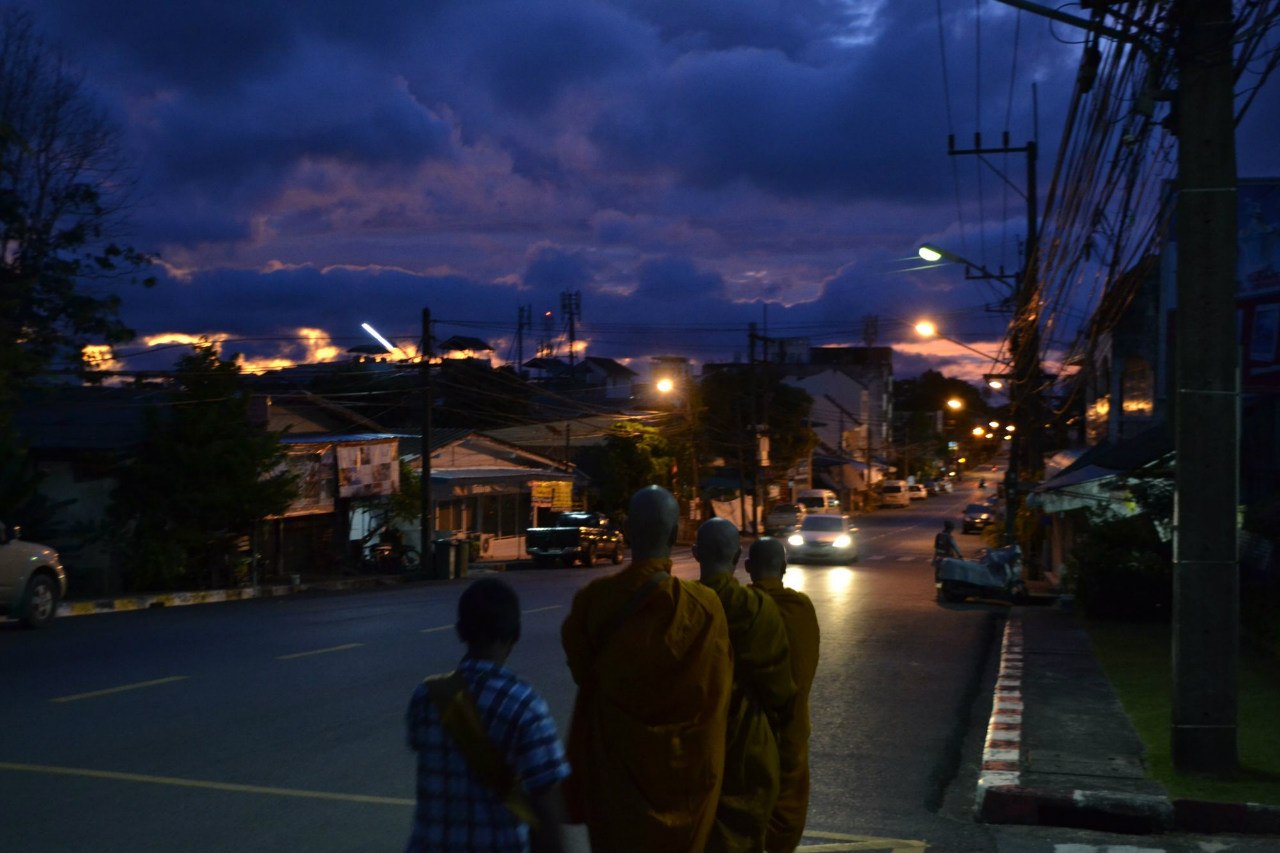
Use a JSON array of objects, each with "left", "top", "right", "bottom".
[{"left": 975, "top": 590, "right": 1280, "bottom": 835}]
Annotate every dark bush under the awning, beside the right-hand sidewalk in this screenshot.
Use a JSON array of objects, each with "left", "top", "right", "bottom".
[{"left": 1068, "top": 504, "right": 1174, "bottom": 619}]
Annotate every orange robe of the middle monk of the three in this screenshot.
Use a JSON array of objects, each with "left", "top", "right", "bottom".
[{"left": 703, "top": 573, "right": 796, "bottom": 853}]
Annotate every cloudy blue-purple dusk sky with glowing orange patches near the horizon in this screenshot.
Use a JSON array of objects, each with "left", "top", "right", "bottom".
[{"left": 31, "top": 0, "right": 1280, "bottom": 378}]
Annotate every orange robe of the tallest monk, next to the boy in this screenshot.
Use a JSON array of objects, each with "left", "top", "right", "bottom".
[{"left": 561, "top": 560, "right": 733, "bottom": 853}]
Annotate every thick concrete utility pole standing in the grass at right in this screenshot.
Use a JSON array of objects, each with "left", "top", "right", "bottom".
[{"left": 1172, "top": 0, "right": 1240, "bottom": 772}]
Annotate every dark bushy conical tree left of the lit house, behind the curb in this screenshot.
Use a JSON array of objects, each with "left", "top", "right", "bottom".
[{"left": 110, "top": 346, "right": 296, "bottom": 588}]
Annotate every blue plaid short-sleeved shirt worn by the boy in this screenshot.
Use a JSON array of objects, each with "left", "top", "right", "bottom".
[{"left": 406, "top": 658, "right": 568, "bottom": 853}]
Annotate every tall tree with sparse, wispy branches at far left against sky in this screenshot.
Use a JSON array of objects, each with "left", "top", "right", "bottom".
[{"left": 0, "top": 8, "right": 155, "bottom": 417}]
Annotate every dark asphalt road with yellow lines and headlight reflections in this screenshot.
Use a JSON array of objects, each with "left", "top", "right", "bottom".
[{"left": 0, "top": 473, "right": 1269, "bottom": 853}]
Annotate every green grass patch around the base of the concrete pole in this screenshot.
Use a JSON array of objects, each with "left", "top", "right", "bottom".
[{"left": 1085, "top": 620, "right": 1280, "bottom": 806}]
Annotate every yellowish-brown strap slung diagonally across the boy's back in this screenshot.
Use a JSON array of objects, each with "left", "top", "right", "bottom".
[{"left": 424, "top": 670, "right": 538, "bottom": 829}]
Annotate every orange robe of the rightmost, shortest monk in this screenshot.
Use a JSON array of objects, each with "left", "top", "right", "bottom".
[{"left": 751, "top": 578, "right": 819, "bottom": 853}]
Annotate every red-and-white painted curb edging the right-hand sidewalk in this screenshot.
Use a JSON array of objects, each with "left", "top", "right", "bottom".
[{"left": 974, "top": 615, "right": 1280, "bottom": 835}]
